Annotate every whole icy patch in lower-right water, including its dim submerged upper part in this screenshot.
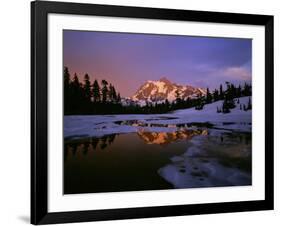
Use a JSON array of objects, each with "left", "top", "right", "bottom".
[{"left": 158, "top": 128, "right": 251, "bottom": 188}]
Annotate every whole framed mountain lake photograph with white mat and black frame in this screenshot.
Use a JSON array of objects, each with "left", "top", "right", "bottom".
[{"left": 31, "top": 1, "right": 273, "bottom": 224}]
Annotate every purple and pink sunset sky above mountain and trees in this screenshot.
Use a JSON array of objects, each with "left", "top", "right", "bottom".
[{"left": 63, "top": 30, "right": 252, "bottom": 97}]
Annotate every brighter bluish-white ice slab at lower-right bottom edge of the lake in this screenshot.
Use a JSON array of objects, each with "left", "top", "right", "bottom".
[{"left": 158, "top": 154, "right": 251, "bottom": 188}]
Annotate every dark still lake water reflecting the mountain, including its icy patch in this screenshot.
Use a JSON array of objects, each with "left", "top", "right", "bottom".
[{"left": 64, "top": 128, "right": 249, "bottom": 194}]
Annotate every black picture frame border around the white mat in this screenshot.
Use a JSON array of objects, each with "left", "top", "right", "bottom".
[{"left": 31, "top": 1, "right": 274, "bottom": 224}]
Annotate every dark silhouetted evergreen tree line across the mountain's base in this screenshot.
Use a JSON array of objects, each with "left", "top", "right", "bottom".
[{"left": 64, "top": 67, "right": 252, "bottom": 115}]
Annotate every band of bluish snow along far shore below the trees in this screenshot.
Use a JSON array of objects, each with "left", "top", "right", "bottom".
[{"left": 64, "top": 97, "right": 252, "bottom": 139}]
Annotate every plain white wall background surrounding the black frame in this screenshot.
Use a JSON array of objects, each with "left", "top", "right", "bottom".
[{"left": 0, "top": 0, "right": 281, "bottom": 226}]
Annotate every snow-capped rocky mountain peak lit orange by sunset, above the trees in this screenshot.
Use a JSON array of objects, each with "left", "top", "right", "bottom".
[{"left": 131, "top": 77, "right": 206, "bottom": 102}]
